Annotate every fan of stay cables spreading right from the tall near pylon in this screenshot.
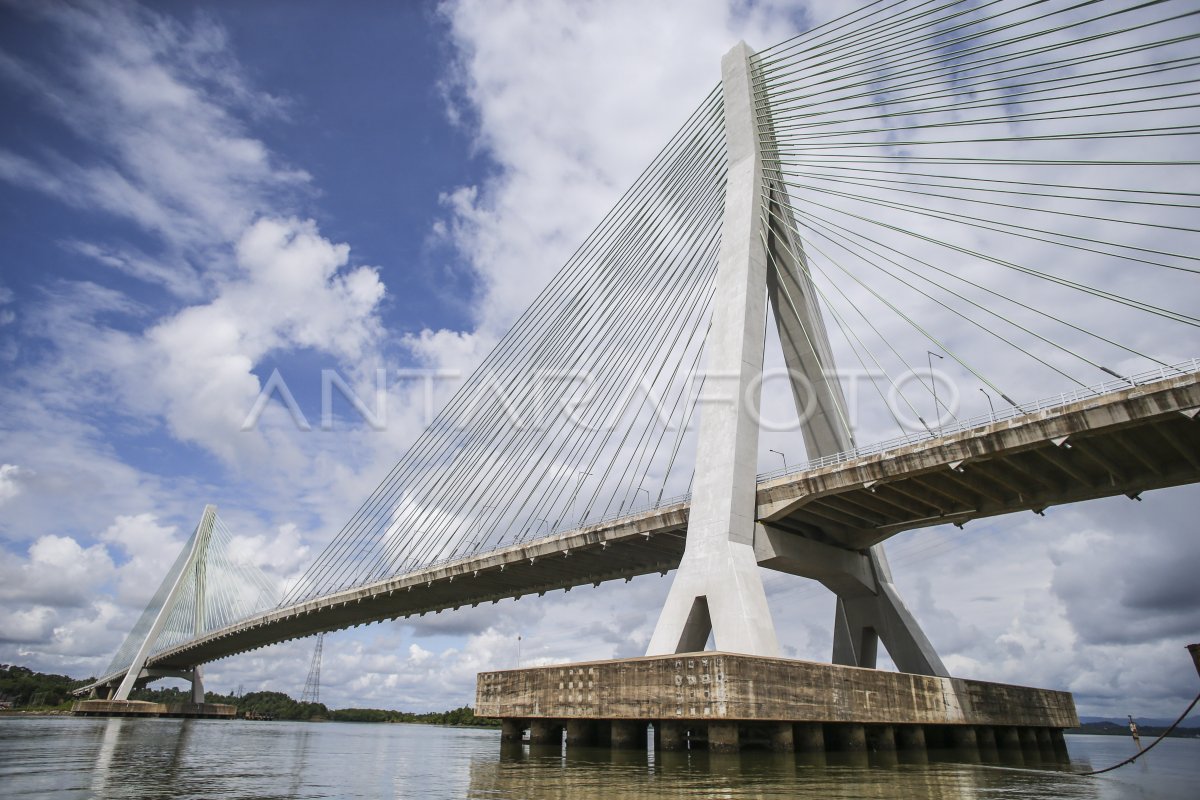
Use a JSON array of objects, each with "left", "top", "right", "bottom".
[{"left": 754, "top": 0, "right": 1200, "bottom": 448}]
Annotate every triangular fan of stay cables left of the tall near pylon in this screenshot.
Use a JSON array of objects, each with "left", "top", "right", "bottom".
[{"left": 284, "top": 90, "right": 726, "bottom": 603}]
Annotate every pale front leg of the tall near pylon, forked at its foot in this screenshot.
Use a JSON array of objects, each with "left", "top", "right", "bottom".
[{"left": 647, "top": 42, "right": 779, "bottom": 656}]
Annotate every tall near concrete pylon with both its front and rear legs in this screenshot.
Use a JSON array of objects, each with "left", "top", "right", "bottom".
[{"left": 647, "top": 42, "right": 948, "bottom": 676}]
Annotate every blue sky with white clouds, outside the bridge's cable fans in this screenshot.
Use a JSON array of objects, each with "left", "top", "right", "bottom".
[{"left": 0, "top": 0, "right": 1200, "bottom": 715}]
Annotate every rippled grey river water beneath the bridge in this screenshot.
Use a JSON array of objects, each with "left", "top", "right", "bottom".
[{"left": 0, "top": 717, "right": 1200, "bottom": 800}]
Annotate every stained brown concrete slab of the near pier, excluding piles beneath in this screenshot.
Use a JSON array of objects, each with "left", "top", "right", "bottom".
[{"left": 475, "top": 651, "right": 1079, "bottom": 728}]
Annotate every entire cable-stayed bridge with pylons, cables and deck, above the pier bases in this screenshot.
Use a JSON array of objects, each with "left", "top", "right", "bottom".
[{"left": 79, "top": 0, "right": 1200, "bottom": 714}]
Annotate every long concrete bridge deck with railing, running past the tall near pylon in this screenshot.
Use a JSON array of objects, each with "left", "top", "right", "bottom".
[{"left": 87, "top": 373, "right": 1200, "bottom": 684}]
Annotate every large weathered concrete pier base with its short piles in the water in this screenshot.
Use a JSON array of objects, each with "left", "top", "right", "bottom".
[{"left": 475, "top": 651, "right": 1079, "bottom": 765}]
